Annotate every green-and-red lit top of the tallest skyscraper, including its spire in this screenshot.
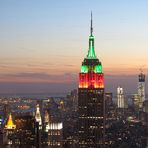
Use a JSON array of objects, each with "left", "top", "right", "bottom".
[{"left": 79, "top": 13, "right": 104, "bottom": 88}]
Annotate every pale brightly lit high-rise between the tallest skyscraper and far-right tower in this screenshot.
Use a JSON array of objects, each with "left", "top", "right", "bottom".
[{"left": 117, "top": 86, "right": 125, "bottom": 108}]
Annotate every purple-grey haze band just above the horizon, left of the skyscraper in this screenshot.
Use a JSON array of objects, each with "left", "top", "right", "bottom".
[{"left": 0, "top": 83, "right": 78, "bottom": 94}]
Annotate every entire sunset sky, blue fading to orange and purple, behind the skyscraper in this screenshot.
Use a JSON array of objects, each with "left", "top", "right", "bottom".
[{"left": 0, "top": 0, "right": 148, "bottom": 93}]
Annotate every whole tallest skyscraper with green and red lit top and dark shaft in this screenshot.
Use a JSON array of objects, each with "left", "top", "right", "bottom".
[{"left": 78, "top": 14, "right": 104, "bottom": 148}]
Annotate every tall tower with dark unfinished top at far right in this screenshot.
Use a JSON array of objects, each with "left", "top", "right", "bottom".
[{"left": 138, "top": 70, "right": 145, "bottom": 108}]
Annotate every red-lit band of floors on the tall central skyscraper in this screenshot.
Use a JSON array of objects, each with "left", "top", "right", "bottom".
[{"left": 79, "top": 73, "right": 104, "bottom": 88}]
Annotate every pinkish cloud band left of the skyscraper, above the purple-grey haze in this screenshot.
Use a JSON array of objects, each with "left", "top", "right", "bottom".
[{"left": 0, "top": 73, "right": 77, "bottom": 83}]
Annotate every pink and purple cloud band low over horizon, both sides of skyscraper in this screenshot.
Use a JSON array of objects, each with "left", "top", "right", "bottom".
[{"left": 0, "top": 72, "right": 148, "bottom": 94}]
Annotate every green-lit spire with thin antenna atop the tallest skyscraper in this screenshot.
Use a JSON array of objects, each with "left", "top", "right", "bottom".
[{"left": 87, "top": 12, "right": 96, "bottom": 59}]
